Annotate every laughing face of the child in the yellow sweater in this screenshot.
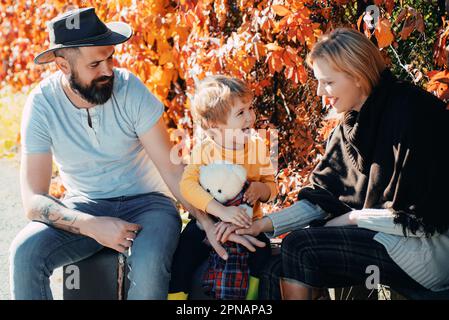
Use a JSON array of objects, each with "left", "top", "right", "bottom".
[{"left": 217, "top": 99, "right": 256, "bottom": 141}]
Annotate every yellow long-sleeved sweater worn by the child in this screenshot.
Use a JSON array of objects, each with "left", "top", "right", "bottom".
[{"left": 179, "top": 137, "right": 278, "bottom": 220}]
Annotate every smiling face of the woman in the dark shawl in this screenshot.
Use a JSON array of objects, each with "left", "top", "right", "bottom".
[{"left": 313, "top": 59, "right": 367, "bottom": 113}]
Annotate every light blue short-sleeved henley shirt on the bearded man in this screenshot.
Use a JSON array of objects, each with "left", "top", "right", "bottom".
[{"left": 21, "top": 68, "right": 170, "bottom": 199}]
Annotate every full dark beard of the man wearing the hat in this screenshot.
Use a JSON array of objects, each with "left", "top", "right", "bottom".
[{"left": 69, "top": 72, "right": 114, "bottom": 105}]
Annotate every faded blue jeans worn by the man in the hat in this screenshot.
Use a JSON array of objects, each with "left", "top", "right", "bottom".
[{"left": 10, "top": 193, "right": 181, "bottom": 300}]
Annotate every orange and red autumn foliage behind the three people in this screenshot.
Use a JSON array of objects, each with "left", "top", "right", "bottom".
[{"left": 0, "top": 0, "right": 449, "bottom": 207}]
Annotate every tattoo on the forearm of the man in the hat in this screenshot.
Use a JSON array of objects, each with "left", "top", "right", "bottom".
[{"left": 32, "top": 194, "right": 80, "bottom": 233}]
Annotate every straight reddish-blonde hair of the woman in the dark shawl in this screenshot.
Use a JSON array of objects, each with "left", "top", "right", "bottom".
[{"left": 307, "top": 28, "right": 385, "bottom": 95}]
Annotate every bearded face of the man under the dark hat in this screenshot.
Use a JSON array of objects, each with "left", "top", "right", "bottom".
[{"left": 69, "top": 46, "right": 114, "bottom": 104}]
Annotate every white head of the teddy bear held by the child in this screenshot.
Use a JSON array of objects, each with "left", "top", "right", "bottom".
[{"left": 200, "top": 161, "right": 253, "bottom": 218}]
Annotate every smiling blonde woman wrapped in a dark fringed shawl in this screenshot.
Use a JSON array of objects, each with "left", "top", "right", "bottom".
[{"left": 234, "top": 29, "right": 449, "bottom": 299}]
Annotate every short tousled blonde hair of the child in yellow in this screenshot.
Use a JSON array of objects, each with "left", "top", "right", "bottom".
[{"left": 191, "top": 75, "right": 253, "bottom": 129}]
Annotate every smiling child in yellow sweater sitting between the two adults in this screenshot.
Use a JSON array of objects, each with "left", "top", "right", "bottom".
[{"left": 169, "top": 76, "right": 277, "bottom": 299}]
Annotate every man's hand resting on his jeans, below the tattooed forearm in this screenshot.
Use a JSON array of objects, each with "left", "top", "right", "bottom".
[{"left": 80, "top": 216, "right": 142, "bottom": 253}]
